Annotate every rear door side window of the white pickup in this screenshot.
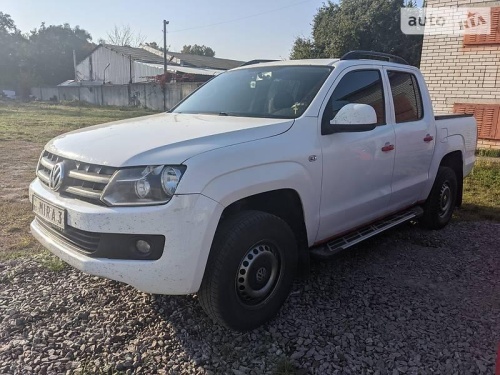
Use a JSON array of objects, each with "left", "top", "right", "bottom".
[{"left": 389, "top": 71, "right": 424, "bottom": 123}]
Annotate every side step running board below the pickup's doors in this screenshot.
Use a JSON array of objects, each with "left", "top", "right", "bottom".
[{"left": 311, "top": 207, "right": 424, "bottom": 259}]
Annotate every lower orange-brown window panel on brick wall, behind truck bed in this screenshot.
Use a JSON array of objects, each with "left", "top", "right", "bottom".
[{"left": 453, "top": 103, "right": 500, "bottom": 140}]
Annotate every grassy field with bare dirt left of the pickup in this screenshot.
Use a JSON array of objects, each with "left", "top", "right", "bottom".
[{"left": 0, "top": 101, "right": 155, "bottom": 262}]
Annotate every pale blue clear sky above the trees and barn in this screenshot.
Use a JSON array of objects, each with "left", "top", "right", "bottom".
[{"left": 0, "top": 0, "right": 426, "bottom": 61}]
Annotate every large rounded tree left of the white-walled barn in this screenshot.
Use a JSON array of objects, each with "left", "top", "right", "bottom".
[{"left": 29, "top": 23, "right": 94, "bottom": 85}]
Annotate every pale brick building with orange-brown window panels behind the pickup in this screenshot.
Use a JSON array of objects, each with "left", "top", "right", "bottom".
[{"left": 420, "top": 0, "right": 500, "bottom": 149}]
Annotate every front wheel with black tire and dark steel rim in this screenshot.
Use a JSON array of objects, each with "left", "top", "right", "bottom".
[{"left": 198, "top": 211, "right": 298, "bottom": 331}]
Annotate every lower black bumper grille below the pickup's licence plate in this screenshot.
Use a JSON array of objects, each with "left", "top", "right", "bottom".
[{"left": 36, "top": 217, "right": 101, "bottom": 255}]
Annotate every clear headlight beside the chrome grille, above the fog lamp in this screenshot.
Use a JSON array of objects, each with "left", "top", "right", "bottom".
[{"left": 101, "top": 165, "right": 186, "bottom": 206}]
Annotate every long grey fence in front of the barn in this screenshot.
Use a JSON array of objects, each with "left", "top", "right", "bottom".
[{"left": 31, "top": 82, "right": 201, "bottom": 111}]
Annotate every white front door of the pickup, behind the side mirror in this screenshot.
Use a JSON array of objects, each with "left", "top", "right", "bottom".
[{"left": 317, "top": 65, "right": 395, "bottom": 241}]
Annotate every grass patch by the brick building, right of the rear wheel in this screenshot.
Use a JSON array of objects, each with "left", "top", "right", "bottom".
[{"left": 455, "top": 158, "right": 500, "bottom": 222}]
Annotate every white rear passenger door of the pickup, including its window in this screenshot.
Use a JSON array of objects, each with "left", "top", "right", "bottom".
[{"left": 385, "top": 68, "right": 436, "bottom": 211}]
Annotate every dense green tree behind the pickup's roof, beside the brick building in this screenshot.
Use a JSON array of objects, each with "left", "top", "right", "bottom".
[{"left": 290, "top": 0, "right": 423, "bottom": 66}]
